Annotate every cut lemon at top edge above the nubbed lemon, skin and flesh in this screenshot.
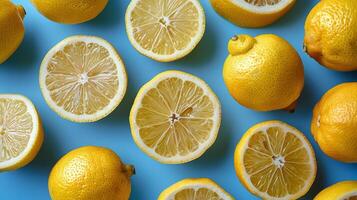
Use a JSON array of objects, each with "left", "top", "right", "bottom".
[{"left": 210, "top": 0, "right": 296, "bottom": 28}]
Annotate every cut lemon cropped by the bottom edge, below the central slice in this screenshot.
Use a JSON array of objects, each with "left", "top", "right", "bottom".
[{"left": 158, "top": 178, "right": 234, "bottom": 200}]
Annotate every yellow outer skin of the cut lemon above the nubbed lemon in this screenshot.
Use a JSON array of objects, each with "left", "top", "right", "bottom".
[{"left": 210, "top": 0, "right": 296, "bottom": 28}]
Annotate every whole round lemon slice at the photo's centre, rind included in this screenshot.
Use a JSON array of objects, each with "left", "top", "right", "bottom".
[{"left": 130, "top": 71, "right": 221, "bottom": 164}]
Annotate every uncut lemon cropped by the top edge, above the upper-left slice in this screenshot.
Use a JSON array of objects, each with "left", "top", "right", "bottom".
[{"left": 31, "top": 0, "right": 108, "bottom": 24}]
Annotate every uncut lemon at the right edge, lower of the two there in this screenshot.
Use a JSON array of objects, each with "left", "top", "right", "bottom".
[{"left": 311, "top": 82, "right": 357, "bottom": 162}]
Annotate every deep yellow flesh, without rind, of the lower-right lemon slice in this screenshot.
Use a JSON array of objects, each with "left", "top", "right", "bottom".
[{"left": 243, "top": 127, "right": 313, "bottom": 197}]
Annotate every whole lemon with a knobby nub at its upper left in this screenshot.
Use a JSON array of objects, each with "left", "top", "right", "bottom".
[{"left": 223, "top": 34, "right": 304, "bottom": 111}]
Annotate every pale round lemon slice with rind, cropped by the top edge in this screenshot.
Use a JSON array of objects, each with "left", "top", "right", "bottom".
[{"left": 125, "top": 0, "right": 206, "bottom": 62}]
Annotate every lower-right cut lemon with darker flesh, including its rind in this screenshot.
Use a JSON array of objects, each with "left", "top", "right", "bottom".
[{"left": 234, "top": 121, "right": 316, "bottom": 200}]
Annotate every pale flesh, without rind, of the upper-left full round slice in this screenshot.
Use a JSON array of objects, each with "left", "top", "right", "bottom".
[{"left": 46, "top": 42, "right": 119, "bottom": 115}]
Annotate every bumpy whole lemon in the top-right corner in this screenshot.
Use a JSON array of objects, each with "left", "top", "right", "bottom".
[{"left": 304, "top": 0, "right": 357, "bottom": 71}]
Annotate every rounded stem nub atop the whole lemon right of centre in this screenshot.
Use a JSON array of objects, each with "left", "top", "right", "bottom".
[{"left": 228, "top": 35, "right": 256, "bottom": 56}]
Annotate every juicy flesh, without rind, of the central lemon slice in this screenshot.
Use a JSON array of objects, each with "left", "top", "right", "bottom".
[{"left": 136, "top": 78, "right": 214, "bottom": 157}]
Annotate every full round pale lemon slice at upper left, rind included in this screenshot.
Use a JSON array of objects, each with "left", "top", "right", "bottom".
[{"left": 40, "top": 36, "right": 127, "bottom": 122}]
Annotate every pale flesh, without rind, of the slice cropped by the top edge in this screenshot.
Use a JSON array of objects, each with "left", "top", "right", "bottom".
[{"left": 130, "top": 0, "right": 199, "bottom": 55}]
